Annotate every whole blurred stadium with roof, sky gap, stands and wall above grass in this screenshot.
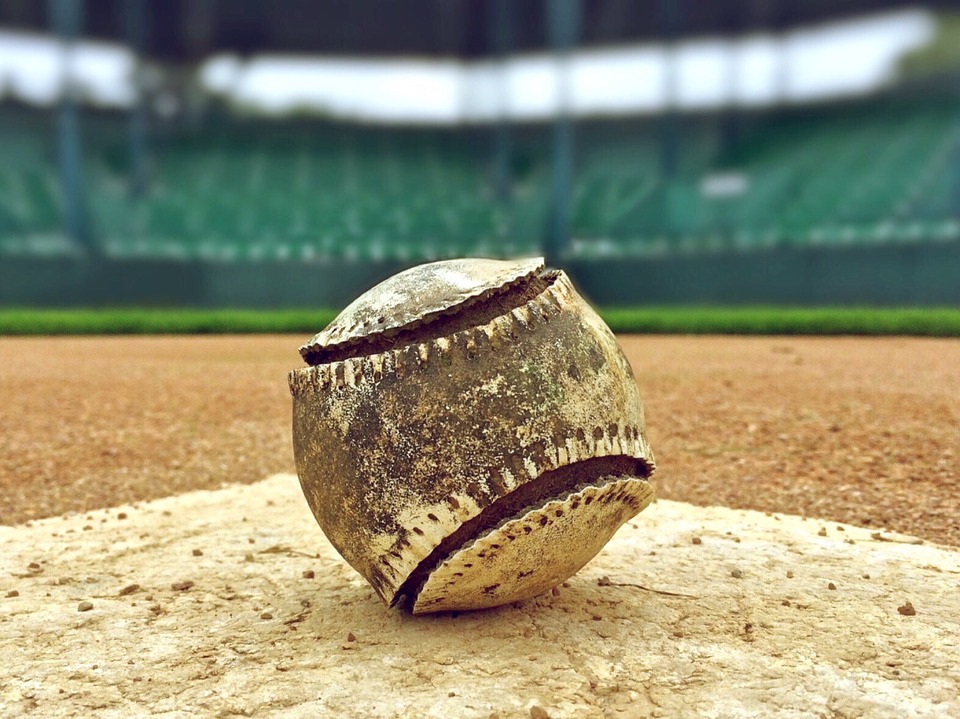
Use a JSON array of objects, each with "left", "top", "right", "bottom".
[{"left": 0, "top": 0, "right": 960, "bottom": 308}]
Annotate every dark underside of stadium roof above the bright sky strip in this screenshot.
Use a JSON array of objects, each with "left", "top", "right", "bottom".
[{"left": 0, "top": 0, "right": 954, "bottom": 61}]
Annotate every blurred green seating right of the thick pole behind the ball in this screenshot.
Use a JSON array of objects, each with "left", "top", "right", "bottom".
[{"left": 572, "top": 104, "right": 960, "bottom": 257}]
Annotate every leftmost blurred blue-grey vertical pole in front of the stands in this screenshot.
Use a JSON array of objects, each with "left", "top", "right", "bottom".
[{"left": 48, "top": 0, "right": 96, "bottom": 253}]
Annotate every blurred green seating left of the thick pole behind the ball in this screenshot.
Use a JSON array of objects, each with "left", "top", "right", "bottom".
[{"left": 88, "top": 125, "right": 542, "bottom": 261}]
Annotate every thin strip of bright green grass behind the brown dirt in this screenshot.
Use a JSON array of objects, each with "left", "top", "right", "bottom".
[{"left": 0, "top": 307, "right": 960, "bottom": 337}]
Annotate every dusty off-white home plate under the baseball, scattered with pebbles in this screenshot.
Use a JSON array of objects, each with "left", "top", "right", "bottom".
[{"left": 0, "top": 475, "right": 960, "bottom": 718}]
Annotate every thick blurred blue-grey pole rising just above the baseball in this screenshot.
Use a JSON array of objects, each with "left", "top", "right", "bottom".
[{"left": 544, "top": 0, "right": 580, "bottom": 262}]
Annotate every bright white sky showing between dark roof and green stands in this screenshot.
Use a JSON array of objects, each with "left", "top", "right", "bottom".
[{"left": 0, "top": 9, "right": 935, "bottom": 124}]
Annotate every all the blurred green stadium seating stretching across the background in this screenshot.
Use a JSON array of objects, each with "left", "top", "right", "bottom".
[{"left": 0, "top": 99, "right": 960, "bottom": 262}]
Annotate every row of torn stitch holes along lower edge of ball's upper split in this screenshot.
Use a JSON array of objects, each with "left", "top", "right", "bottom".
[{"left": 287, "top": 273, "right": 575, "bottom": 397}]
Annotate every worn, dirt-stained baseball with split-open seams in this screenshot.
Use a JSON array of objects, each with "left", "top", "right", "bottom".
[{"left": 289, "top": 259, "right": 654, "bottom": 614}]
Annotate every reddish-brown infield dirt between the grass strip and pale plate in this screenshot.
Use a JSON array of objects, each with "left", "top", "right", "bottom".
[{"left": 0, "top": 336, "right": 960, "bottom": 544}]
